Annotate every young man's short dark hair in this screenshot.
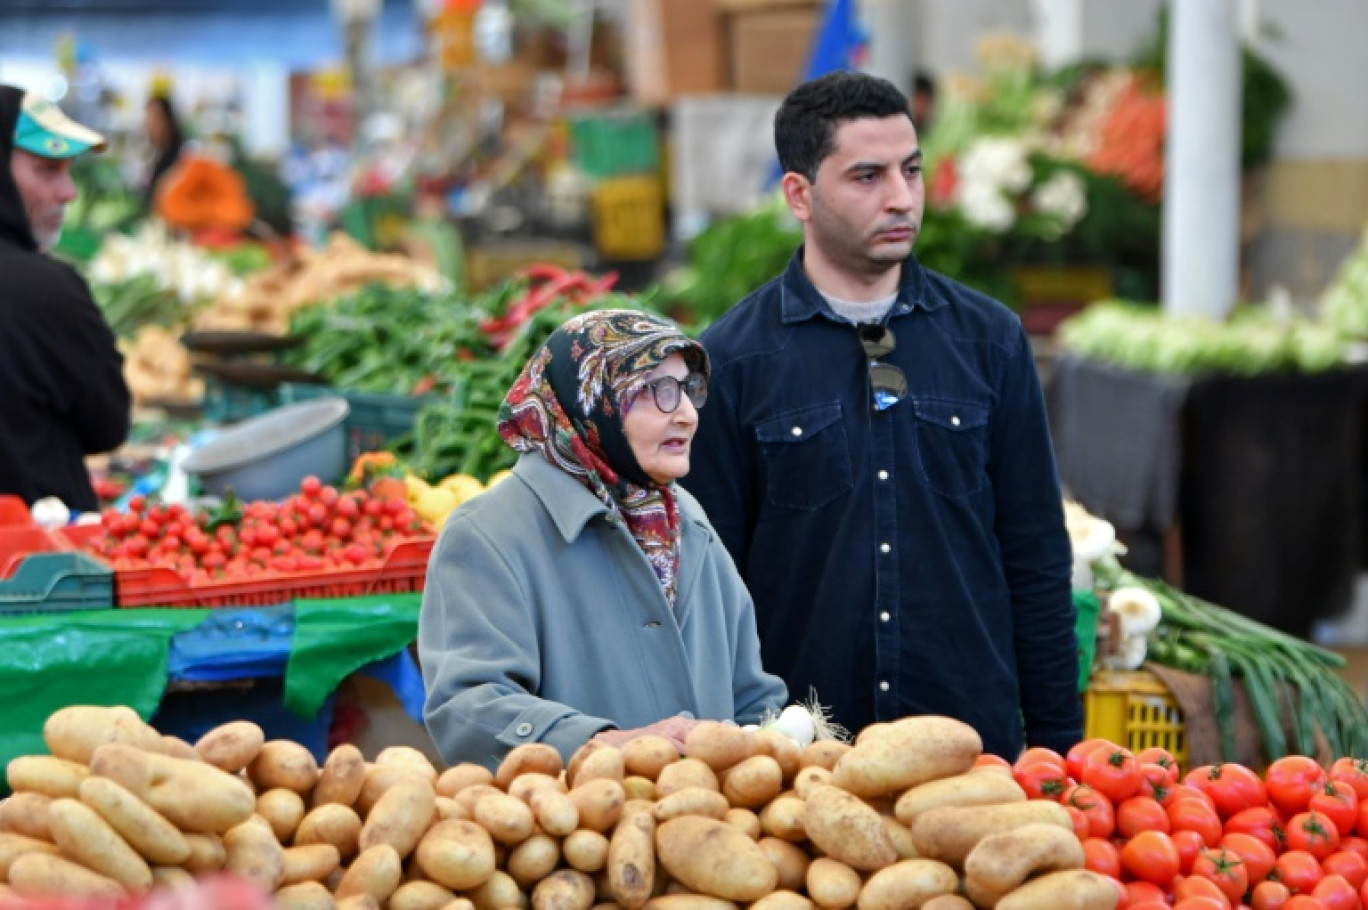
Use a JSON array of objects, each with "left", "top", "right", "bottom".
[{"left": 774, "top": 71, "right": 912, "bottom": 181}]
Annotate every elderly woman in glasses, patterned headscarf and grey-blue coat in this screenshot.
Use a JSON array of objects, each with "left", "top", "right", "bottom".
[{"left": 419, "top": 311, "right": 785, "bottom": 766}]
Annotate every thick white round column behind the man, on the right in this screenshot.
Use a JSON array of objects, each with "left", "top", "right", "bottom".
[{"left": 1161, "top": 0, "right": 1239, "bottom": 319}]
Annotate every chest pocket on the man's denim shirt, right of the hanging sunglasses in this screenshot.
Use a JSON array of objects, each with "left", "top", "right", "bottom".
[{"left": 911, "top": 398, "right": 992, "bottom": 498}]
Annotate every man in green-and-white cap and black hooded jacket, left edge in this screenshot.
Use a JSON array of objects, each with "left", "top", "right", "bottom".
[{"left": 0, "top": 85, "right": 129, "bottom": 512}]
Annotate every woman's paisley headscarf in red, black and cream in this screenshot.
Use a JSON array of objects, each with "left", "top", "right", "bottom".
[{"left": 499, "top": 309, "right": 709, "bottom": 606}]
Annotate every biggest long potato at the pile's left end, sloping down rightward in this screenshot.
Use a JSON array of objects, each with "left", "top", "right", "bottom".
[{"left": 90, "top": 743, "right": 256, "bottom": 833}]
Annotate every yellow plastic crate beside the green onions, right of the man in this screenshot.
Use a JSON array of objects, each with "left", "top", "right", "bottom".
[{"left": 1083, "top": 671, "right": 1187, "bottom": 770}]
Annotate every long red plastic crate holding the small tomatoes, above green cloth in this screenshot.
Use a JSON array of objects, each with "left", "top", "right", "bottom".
[{"left": 114, "top": 538, "right": 436, "bottom": 609}]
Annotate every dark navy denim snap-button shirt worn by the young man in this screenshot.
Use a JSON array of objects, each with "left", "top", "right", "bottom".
[{"left": 684, "top": 249, "right": 1082, "bottom": 758}]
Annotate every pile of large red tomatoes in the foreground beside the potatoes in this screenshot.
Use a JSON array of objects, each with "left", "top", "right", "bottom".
[{"left": 1012, "top": 739, "right": 1368, "bottom": 910}]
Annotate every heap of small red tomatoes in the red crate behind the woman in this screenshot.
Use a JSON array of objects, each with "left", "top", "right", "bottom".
[{"left": 86, "top": 478, "right": 431, "bottom": 584}]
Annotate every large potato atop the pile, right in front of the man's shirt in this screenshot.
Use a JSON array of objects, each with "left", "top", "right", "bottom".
[{"left": 832, "top": 716, "right": 984, "bottom": 796}]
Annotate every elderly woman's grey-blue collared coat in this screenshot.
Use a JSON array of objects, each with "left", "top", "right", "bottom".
[{"left": 419, "top": 454, "right": 787, "bottom": 768}]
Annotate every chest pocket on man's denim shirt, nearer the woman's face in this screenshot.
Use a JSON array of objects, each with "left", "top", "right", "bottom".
[{"left": 755, "top": 401, "right": 855, "bottom": 510}]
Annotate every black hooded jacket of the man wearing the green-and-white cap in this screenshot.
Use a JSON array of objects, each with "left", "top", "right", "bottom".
[{"left": 0, "top": 86, "right": 130, "bottom": 510}]
